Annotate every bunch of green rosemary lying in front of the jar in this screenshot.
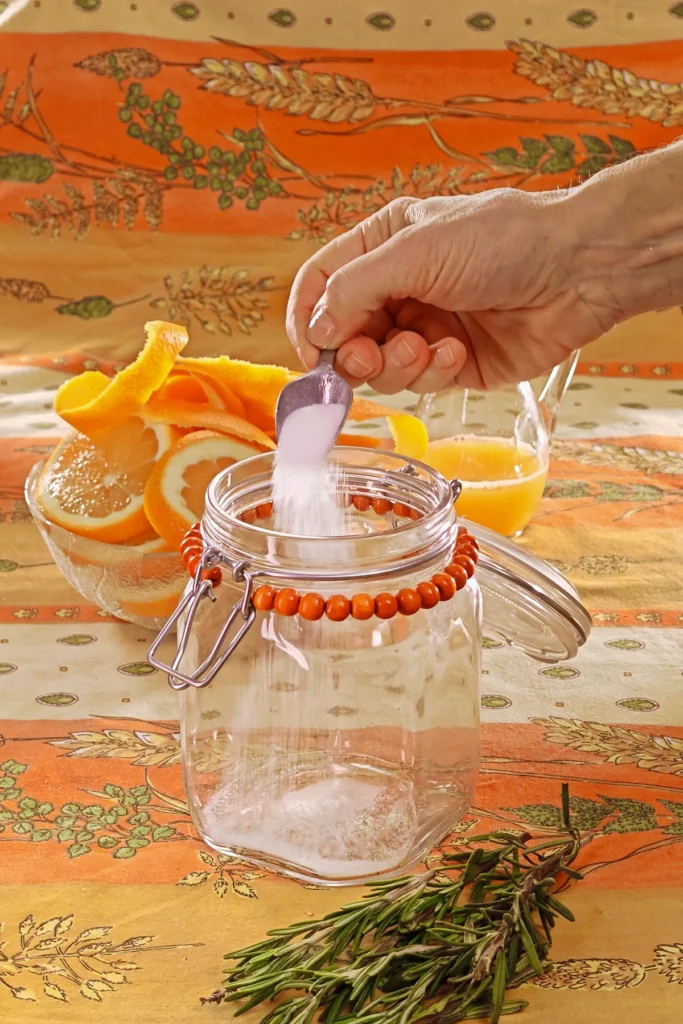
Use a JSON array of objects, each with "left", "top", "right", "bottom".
[{"left": 206, "top": 785, "right": 586, "bottom": 1024}]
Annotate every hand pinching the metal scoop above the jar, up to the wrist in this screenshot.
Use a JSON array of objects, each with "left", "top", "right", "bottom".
[{"left": 287, "top": 188, "right": 621, "bottom": 394}]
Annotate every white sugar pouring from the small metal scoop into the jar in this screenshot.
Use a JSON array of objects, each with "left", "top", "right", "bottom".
[{"left": 272, "top": 406, "right": 346, "bottom": 537}]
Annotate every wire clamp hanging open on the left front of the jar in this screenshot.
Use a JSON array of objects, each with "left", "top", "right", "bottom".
[{"left": 147, "top": 548, "right": 256, "bottom": 690}]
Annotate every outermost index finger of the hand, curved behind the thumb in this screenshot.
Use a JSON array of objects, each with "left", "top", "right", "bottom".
[{"left": 286, "top": 199, "right": 416, "bottom": 370}]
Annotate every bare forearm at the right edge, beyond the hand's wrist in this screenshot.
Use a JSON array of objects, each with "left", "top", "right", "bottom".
[{"left": 565, "top": 140, "right": 683, "bottom": 322}]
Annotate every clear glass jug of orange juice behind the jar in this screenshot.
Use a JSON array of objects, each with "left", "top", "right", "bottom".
[{"left": 415, "top": 352, "right": 579, "bottom": 537}]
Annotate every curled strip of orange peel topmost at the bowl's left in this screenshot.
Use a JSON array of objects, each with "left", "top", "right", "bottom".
[{"left": 54, "top": 321, "right": 187, "bottom": 437}]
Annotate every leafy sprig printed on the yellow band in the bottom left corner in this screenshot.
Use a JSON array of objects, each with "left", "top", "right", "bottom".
[{"left": 0, "top": 913, "right": 202, "bottom": 1002}]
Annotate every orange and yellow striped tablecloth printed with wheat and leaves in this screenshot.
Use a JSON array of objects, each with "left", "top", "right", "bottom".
[{"left": 0, "top": 0, "right": 683, "bottom": 1024}]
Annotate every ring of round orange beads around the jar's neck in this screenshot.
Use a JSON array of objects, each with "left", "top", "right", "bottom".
[{"left": 180, "top": 495, "right": 479, "bottom": 623}]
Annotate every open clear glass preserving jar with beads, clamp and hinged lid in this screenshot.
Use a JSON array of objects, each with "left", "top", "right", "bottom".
[{"left": 150, "top": 447, "right": 590, "bottom": 885}]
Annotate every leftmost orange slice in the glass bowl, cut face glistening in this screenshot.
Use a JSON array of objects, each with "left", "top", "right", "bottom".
[{"left": 36, "top": 416, "right": 177, "bottom": 544}]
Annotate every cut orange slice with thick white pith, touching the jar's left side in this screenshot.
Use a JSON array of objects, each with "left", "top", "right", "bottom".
[{"left": 144, "top": 428, "right": 272, "bottom": 550}]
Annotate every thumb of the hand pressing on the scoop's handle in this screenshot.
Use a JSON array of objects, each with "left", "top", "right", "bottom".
[{"left": 306, "top": 226, "right": 428, "bottom": 348}]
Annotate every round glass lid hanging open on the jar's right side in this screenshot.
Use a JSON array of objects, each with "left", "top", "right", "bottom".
[{"left": 458, "top": 519, "right": 591, "bottom": 664}]
